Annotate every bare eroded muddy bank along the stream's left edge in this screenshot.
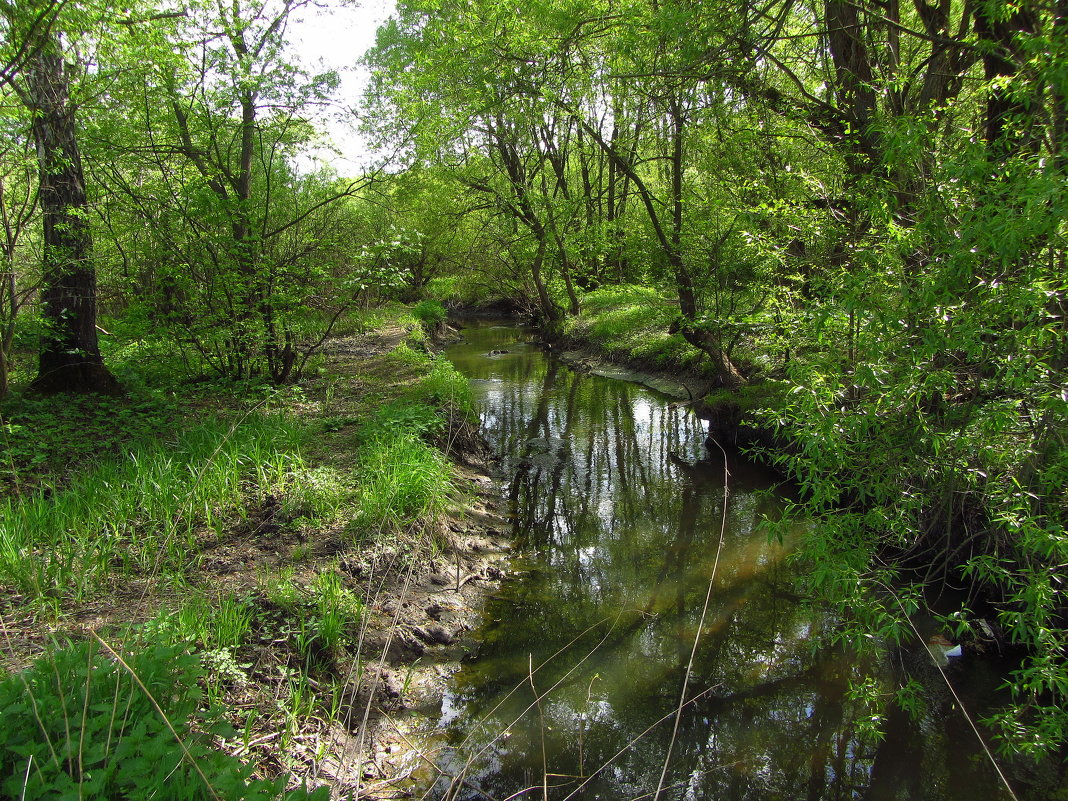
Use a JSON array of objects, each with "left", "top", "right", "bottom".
[{"left": 319, "top": 464, "right": 512, "bottom": 799}]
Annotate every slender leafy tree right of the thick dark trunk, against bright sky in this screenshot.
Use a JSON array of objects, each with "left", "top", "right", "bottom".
[{"left": 94, "top": 0, "right": 372, "bottom": 382}]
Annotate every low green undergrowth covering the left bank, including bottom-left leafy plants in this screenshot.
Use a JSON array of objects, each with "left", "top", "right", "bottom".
[{"left": 0, "top": 308, "right": 474, "bottom": 799}]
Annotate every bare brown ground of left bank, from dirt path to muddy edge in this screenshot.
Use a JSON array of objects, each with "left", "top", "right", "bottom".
[{"left": 0, "top": 311, "right": 511, "bottom": 800}]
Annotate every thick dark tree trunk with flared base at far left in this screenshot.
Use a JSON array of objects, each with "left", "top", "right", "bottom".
[{"left": 26, "top": 35, "right": 120, "bottom": 394}]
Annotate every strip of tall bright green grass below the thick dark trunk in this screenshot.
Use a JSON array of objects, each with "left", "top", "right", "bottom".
[{"left": 0, "top": 415, "right": 300, "bottom": 599}]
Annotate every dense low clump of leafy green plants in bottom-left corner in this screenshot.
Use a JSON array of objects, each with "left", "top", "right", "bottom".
[{"left": 0, "top": 642, "right": 329, "bottom": 801}]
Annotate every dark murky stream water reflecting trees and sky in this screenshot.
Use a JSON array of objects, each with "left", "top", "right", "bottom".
[{"left": 433, "top": 326, "right": 1021, "bottom": 801}]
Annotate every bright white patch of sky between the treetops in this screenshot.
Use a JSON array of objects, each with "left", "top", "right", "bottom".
[{"left": 287, "top": 0, "right": 395, "bottom": 176}]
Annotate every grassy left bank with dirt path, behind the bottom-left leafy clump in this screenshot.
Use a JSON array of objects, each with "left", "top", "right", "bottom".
[{"left": 0, "top": 309, "right": 484, "bottom": 798}]
